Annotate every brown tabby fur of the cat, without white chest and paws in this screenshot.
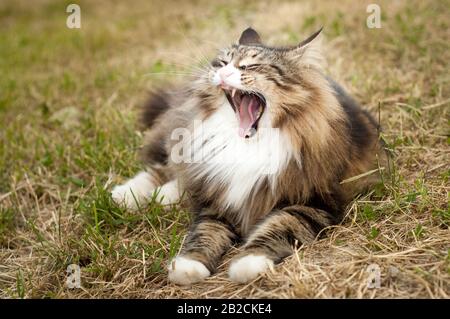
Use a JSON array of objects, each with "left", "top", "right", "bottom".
[{"left": 136, "top": 28, "right": 386, "bottom": 278}]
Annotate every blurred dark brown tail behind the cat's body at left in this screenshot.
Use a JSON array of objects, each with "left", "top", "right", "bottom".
[{"left": 141, "top": 90, "right": 170, "bottom": 130}]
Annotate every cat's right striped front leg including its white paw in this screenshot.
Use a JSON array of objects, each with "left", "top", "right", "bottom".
[{"left": 229, "top": 205, "right": 334, "bottom": 283}]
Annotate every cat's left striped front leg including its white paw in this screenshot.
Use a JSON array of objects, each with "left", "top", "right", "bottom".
[{"left": 168, "top": 216, "right": 237, "bottom": 285}]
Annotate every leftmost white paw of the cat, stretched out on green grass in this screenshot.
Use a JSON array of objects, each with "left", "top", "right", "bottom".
[{"left": 111, "top": 172, "right": 155, "bottom": 210}]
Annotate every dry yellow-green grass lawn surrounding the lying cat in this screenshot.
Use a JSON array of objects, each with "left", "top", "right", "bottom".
[{"left": 0, "top": 0, "right": 450, "bottom": 298}]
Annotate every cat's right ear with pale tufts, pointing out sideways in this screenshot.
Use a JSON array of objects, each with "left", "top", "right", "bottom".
[{"left": 289, "top": 27, "right": 324, "bottom": 68}]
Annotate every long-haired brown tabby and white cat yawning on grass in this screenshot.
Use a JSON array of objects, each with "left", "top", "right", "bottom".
[{"left": 112, "top": 28, "right": 386, "bottom": 285}]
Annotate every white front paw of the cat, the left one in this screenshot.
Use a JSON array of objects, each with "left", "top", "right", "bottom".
[{"left": 169, "top": 256, "right": 211, "bottom": 285}]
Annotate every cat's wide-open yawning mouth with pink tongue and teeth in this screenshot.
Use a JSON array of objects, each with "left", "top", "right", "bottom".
[{"left": 223, "top": 88, "right": 266, "bottom": 138}]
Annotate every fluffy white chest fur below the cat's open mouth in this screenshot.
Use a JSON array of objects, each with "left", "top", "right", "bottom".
[{"left": 186, "top": 104, "right": 292, "bottom": 210}]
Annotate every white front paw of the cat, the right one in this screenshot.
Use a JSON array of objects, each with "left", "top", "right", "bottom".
[{"left": 228, "top": 255, "right": 273, "bottom": 284}]
